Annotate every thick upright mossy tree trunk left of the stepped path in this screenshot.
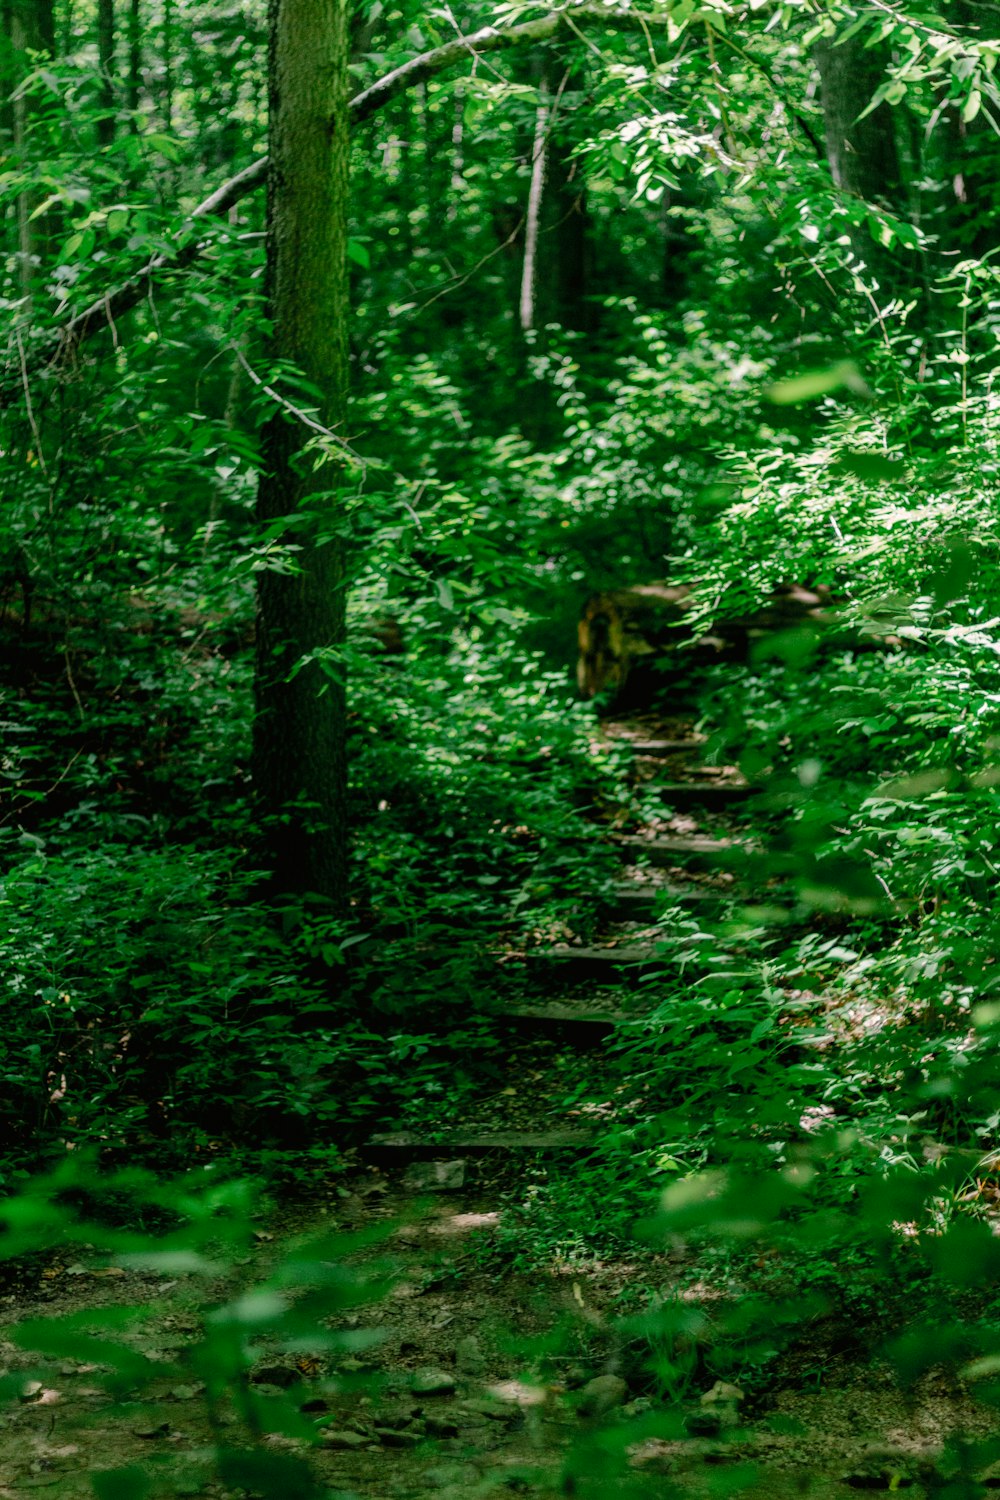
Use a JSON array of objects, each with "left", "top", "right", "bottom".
[{"left": 253, "top": 0, "right": 349, "bottom": 909}]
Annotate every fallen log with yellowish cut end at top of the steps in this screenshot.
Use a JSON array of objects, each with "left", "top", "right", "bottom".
[{"left": 577, "top": 582, "right": 851, "bottom": 707}]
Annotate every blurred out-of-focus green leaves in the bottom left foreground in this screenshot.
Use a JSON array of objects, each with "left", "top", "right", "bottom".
[{"left": 0, "top": 1154, "right": 390, "bottom": 1500}]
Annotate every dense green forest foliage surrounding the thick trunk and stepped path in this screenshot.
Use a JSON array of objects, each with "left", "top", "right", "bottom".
[{"left": 7, "top": 0, "right": 1000, "bottom": 1497}]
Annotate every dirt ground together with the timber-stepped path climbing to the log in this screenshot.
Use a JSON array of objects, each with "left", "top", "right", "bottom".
[{"left": 0, "top": 708, "right": 1000, "bottom": 1500}]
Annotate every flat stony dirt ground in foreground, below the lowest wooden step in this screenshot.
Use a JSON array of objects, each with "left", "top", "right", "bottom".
[{"left": 0, "top": 1170, "right": 1000, "bottom": 1500}]
